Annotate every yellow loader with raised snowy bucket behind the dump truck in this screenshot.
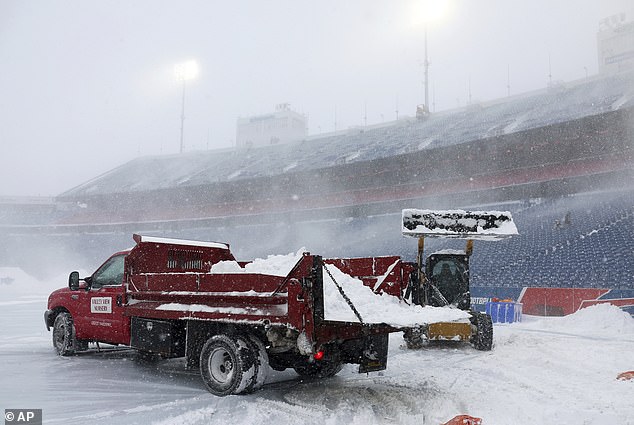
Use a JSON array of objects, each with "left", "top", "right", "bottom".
[{"left": 402, "top": 209, "right": 517, "bottom": 350}]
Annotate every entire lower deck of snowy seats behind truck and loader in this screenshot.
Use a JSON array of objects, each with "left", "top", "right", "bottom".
[{"left": 131, "top": 188, "right": 634, "bottom": 289}]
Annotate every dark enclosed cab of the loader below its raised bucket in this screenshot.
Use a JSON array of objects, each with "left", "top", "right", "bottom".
[{"left": 425, "top": 250, "right": 471, "bottom": 310}]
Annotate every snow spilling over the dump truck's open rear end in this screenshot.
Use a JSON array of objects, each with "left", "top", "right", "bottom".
[{"left": 324, "top": 264, "right": 470, "bottom": 327}]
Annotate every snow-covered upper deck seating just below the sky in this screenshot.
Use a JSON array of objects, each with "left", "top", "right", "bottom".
[{"left": 59, "top": 73, "right": 634, "bottom": 200}]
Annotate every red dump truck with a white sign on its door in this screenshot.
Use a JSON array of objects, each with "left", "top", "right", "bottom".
[{"left": 44, "top": 235, "right": 398, "bottom": 396}]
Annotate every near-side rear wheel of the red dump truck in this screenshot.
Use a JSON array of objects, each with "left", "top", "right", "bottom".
[{"left": 200, "top": 334, "right": 255, "bottom": 397}]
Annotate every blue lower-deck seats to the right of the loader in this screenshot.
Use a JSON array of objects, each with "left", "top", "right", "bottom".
[{"left": 472, "top": 190, "right": 634, "bottom": 289}]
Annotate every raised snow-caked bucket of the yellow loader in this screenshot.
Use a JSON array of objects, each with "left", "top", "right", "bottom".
[{"left": 402, "top": 209, "right": 518, "bottom": 240}]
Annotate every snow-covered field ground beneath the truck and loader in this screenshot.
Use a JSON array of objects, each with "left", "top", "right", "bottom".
[{"left": 0, "top": 269, "right": 634, "bottom": 425}]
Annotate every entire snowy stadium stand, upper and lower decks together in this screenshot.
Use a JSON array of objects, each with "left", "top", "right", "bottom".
[{"left": 0, "top": 73, "right": 634, "bottom": 289}]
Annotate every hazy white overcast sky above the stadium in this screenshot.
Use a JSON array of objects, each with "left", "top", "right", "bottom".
[{"left": 0, "top": 0, "right": 634, "bottom": 196}]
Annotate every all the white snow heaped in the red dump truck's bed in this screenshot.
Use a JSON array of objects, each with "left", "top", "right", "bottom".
[{"left": 210, "top": 248, "right": 470, "bottom": 327}]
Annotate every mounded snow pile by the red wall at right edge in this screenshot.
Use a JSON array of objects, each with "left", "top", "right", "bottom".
[{"left": 540, "top": 303, "right": 634, "bottom": 337}]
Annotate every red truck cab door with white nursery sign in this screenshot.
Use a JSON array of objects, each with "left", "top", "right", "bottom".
[{"left": 75, "top": 254, "right": 130, "bottom": 345}]
